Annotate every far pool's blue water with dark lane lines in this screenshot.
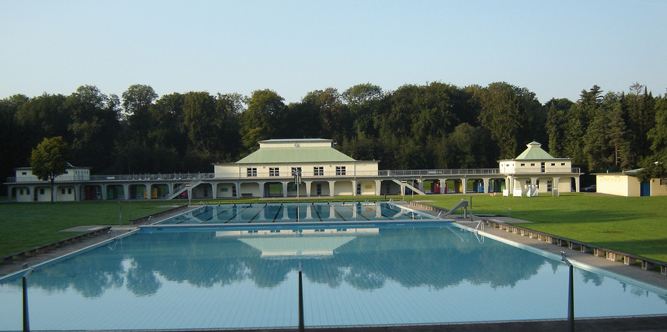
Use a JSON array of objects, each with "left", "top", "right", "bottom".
[{"left": 161, "top": 202, "right": 433, "bottom": 225}]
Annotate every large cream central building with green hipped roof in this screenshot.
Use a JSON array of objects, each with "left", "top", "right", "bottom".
[{"left": 214, "top": 138, "right": 381, "bottom": 197}]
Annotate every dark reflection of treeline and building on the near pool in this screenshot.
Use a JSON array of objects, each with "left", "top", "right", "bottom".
[{"left": 3, "top": 226, "right": 664, "bottom": 304}]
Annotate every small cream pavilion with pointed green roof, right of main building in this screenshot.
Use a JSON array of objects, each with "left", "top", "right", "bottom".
[{"left": 498, "top": 141, "right": 581, "bottom": 196}]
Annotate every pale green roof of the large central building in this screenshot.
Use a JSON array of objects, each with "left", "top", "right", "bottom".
[{"left": 236, "top": 147, "right": 355, "bottom": 164}]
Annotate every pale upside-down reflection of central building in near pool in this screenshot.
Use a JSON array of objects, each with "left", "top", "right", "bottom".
[{"left": 215, "top": 228, "right": 380, "bottom": 258}]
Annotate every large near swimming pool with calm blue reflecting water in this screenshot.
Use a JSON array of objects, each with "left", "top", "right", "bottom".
[{"left": 0, "top": 202, "right": 667, "bottom": 330}]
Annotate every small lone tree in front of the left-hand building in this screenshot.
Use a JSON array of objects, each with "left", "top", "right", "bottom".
[{"left": 30, "top": 136, "right": 67, "bottom": 203}]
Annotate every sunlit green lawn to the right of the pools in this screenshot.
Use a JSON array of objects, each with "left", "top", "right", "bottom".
[{"left": 415, "top": 193, "right": 667, "bottom": 261}]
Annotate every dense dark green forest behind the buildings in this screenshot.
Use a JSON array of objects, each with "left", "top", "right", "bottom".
[{"left": 0, "top": 82, "right": 667, "bottom": 180}]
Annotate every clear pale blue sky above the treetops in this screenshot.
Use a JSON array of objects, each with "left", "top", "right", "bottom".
[{"left": 0, "top": 0, "right": 667, "bottom": 102}]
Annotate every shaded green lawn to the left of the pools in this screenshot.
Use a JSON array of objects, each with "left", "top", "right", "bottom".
[{"left": 0, "top": 202, "right": 177, "bottom": 257}]
